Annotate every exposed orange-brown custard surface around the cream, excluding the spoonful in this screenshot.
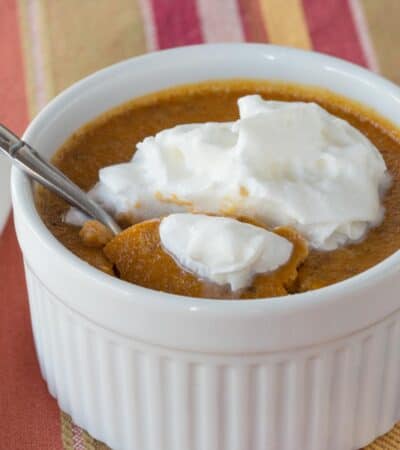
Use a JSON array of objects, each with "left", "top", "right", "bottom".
[{"left": 36, "top": 80, "right": 400, "bottom": 297}]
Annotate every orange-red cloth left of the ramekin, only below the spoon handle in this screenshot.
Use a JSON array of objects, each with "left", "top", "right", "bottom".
[{"left": 0, "top": 229, "right": 62, "bottom": 450}]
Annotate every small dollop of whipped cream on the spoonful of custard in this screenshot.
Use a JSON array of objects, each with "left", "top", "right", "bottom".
[{"left": 160, "top": 213, "right": 293, "bottom": 291}]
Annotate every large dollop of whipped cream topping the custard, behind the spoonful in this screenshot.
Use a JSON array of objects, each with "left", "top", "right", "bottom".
[{"left": 67, "top": 95, "right": 389, "bottom": 250}]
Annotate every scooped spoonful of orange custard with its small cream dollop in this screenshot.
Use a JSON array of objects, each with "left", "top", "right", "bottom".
[{"left": 80, "top": 214, "right": 308, "bottom": 299}]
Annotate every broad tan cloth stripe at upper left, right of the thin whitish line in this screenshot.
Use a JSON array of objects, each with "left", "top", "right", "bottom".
[{"left": 41, "top": 0, "right": 146, "bottom": 93}]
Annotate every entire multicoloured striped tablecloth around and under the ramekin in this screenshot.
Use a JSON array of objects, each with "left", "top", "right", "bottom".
[{"left": 0, "top": 0, "right": 400, "bottom": 450}]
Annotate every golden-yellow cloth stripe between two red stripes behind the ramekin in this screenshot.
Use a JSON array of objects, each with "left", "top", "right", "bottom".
[{"left": 259, "top": 0, "right": 311, "bottom": 49}]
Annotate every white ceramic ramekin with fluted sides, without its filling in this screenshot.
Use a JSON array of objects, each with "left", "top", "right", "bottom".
[{"left": 12, "top": 44, "right": 400, "bottom": 450}]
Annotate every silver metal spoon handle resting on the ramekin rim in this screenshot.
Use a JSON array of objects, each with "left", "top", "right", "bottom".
[{"left": 0, "top": 124, "right": 121, "bottom": 234}]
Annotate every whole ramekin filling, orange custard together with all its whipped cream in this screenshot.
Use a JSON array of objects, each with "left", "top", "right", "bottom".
[{"left": 35, "top": 80, "right": 400, "bottom": 299}]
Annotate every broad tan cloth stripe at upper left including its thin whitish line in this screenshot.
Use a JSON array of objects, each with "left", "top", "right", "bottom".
[{"left": 18, "top": 0, "right": 146, "bottom": 110}]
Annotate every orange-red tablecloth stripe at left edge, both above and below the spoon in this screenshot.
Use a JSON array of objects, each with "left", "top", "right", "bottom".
[{"left": 0, "top": 4, "right": 61, "bottom": 450}]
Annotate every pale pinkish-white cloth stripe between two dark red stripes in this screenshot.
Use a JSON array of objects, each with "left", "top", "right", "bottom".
[{"left": 197, "top": 0, "right": 244, "bottom": 42}]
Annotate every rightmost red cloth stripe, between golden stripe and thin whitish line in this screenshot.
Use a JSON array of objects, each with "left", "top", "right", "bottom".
[{"left": 303, "top": 0, "right": 367, "bottom": 66}]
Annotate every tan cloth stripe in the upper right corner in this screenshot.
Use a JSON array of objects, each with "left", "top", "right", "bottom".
[{"left": 360, "top": 0, "right": 400, "bottom": 84}]
